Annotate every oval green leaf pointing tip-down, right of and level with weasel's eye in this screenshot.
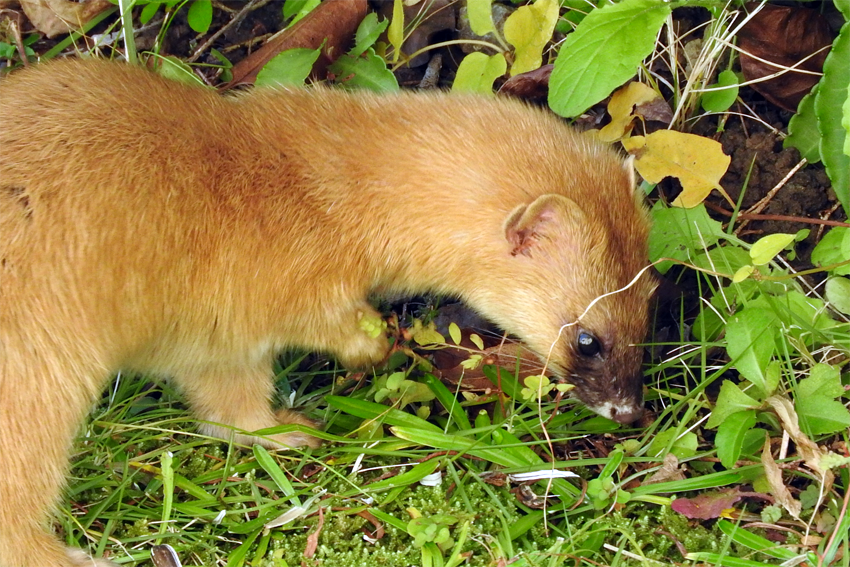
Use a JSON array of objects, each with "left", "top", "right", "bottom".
[{"left": 726, "top": 309, "right": 778, "bottom": 395}]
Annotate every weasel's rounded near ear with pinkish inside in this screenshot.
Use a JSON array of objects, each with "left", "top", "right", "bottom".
[{"left": 502, "top": 195, "right": 585, "bottom": 256}]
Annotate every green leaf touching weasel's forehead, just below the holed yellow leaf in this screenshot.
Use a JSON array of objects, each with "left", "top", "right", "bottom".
[{"left": 649, "top": 202, "right": 724, "bottom": 274}]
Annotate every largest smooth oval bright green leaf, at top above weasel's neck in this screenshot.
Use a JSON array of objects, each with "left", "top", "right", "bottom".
[{"left": 549, "top": 0, "right": 672, "bottom": 117}]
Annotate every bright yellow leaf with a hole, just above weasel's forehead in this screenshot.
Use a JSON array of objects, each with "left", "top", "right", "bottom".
[{"left": 623, "top": 130, "right": 731, "bottom": 208}]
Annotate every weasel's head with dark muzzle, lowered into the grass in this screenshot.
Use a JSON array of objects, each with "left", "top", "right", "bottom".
[{"left": 482, "top": 153, "right": 656, "bottom": 423}]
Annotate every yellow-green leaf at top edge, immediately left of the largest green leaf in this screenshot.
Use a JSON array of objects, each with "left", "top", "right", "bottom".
[{"left": 505, "top": 0, "right": 559, "bottom": 77}]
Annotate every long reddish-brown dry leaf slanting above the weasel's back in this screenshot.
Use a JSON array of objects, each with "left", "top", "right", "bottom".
[{"left": 221, "top": 0, "right": 368, "bottom": 90}]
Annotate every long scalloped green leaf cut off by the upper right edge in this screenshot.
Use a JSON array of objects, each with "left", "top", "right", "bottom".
[{"left": 815, "top": 22, "right": 850, "bottom": 214}]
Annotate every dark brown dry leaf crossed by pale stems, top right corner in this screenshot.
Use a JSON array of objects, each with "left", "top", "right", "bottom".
[{"left": 737, "top": 3, "right": 832, "bottom": 112}]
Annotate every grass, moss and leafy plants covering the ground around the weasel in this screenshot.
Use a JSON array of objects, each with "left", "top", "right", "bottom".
[{"left": 0, "top": 0, "right": 850, "bottom": 567}]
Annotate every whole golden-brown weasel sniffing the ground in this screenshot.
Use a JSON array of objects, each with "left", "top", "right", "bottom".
[{"left": 0, "top": 60, "right": 653, "bottom": 567}]
